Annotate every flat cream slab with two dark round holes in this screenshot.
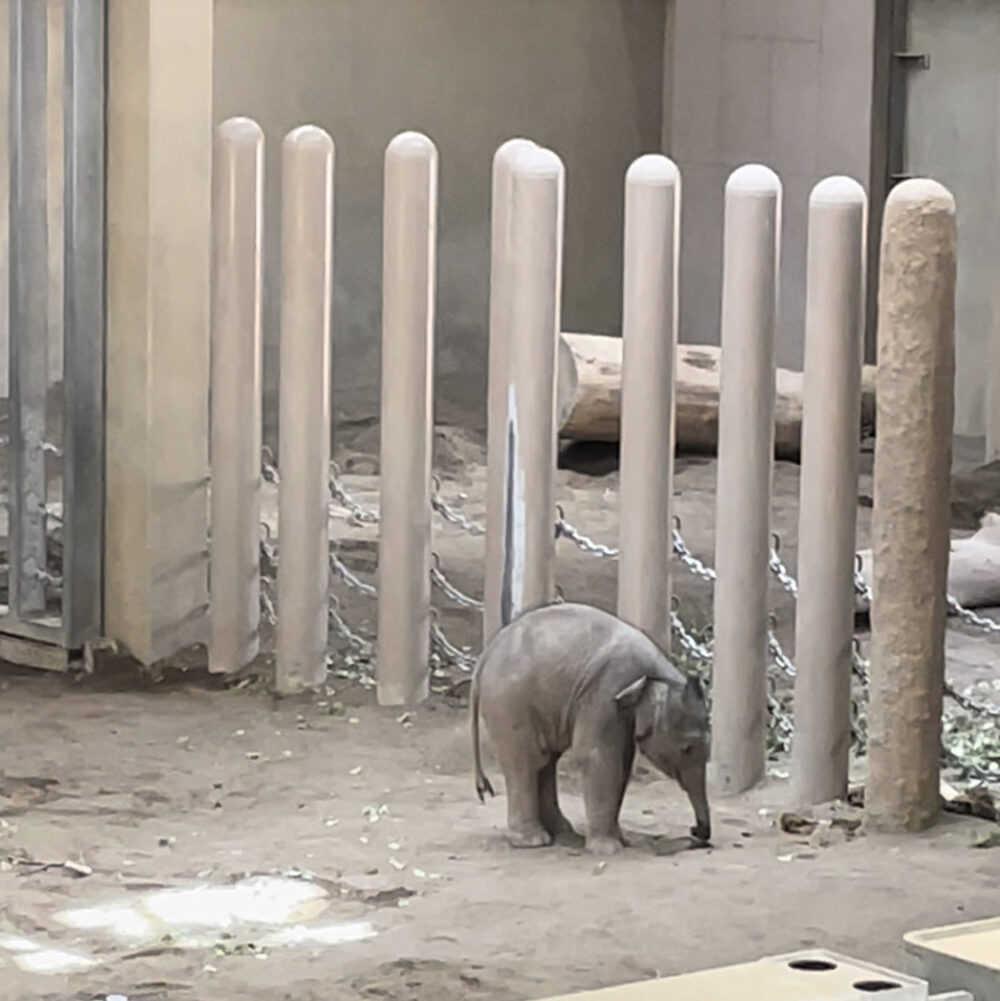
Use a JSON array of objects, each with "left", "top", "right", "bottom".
[{"left": 532, "top": 949, "right": 928, "bottom": 1001}]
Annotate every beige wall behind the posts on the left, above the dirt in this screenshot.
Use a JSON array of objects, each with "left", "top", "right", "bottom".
[{"left": 215, "top": 0, "right": 666, "bottom": 432}]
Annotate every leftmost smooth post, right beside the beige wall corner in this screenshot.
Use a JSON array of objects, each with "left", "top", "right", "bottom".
[{"left": 208, "top": 118, "right": 264, "bottom": 673}]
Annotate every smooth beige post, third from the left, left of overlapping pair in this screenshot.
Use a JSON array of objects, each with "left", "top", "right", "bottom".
[{"left": 375, "top": 132, "right": 437, "bottom": 706}]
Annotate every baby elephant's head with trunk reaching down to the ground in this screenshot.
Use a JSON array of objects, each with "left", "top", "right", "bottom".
[{"left": 616, "top": 675, "right": 712, "bottom": 842}]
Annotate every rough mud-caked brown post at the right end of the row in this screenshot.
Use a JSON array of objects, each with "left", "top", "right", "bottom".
[{"left": 865, "top": 179, "right": 956, "bottom": 831}]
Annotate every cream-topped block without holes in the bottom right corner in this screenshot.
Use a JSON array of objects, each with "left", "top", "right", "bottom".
[{"left": 903, "top": 918, "right": 1000, "bottom": 1001}]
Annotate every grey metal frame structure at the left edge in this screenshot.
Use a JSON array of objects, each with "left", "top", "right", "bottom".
[{"left": 0, "top": 0, "right": 106, "bottom": 668}]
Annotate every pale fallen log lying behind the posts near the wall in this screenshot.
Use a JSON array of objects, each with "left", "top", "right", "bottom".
[{"left": 557, "top": 333, "right": 875, "bottom": 461}]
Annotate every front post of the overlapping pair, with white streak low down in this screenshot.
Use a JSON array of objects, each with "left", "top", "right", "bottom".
[{"left": 501, "top": 148, "right": 564, "bottom": 622}]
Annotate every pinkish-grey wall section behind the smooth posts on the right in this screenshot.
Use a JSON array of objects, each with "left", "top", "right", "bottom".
[{"left": 668, "top": 0, "right": 875, "bottom": 368}]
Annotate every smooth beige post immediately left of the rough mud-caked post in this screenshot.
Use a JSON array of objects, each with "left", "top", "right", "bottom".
[{"left": 792, "top": 177, "right": 867, "bottom": 805}]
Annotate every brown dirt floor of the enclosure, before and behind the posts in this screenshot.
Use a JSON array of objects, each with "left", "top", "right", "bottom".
[{"left": 0, "top": 427, "right": 1000, "bottom": 1001}]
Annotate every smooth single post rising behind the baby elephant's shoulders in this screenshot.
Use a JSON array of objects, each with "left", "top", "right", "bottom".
[{"left": 618, "top": 153, "right": 681, "bottom": 651}]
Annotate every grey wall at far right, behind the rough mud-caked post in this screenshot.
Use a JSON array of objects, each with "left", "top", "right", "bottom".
[{"left": 905, "top": 0, "right": 1000, "bottom": 440}]
